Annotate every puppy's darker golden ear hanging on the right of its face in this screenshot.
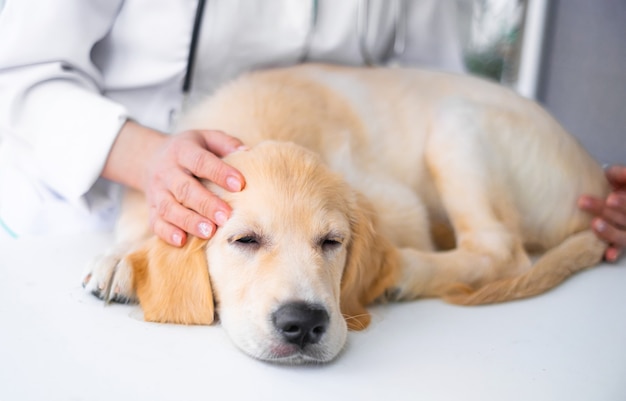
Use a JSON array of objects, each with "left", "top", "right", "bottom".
[{"left": 341, "top": 194, "right": 399, "bottom": 330}]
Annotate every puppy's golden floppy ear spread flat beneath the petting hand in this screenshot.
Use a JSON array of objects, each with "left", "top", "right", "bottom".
[{"left": 127, "top": 237, "right": 215, "bottom": 324}]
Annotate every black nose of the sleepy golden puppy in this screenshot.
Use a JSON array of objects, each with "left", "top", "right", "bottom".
[{"left": 272, "top": 302, "right": 330, "bottom": 348}]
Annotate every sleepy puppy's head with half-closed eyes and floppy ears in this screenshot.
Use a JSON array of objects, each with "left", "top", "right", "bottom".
[{"left": 130, "top": 142, "right": 395, "bottom": 363}]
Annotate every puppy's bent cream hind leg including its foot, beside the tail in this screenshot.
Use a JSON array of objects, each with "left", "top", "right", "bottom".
[{"left": 380, "top": 101, "right": 530, "bottom": 299}]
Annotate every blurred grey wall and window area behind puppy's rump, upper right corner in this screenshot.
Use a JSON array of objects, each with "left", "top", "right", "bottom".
[{"left": 456, "top": 0, "right": 626, "bottom": 164}]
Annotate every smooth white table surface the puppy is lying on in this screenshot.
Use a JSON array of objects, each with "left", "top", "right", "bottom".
[{"left": 0, "top": 234, "right": 626, "bottom": 401}]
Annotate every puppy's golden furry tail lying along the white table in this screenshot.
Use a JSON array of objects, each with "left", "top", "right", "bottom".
[{"left": 443, "top": 230, "right": 606, "bottom": 305}]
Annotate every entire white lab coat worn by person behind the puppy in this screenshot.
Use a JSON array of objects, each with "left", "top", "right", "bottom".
[{"left": 0, "top": 0, "right": 463, "bottom": 236}]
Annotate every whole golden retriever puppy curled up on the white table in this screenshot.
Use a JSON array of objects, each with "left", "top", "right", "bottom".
[{"left": 84, "top": 65, "right": 608, "bottom": 363}]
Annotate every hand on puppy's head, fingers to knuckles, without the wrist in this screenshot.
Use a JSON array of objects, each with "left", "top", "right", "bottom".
[{"left": 144, "top": 130, "right": 245, "bottom": 246}]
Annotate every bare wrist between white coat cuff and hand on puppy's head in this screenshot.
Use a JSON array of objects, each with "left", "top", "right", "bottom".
[{"left": 102, "top": 120, "right": 167, "bottom": 191}]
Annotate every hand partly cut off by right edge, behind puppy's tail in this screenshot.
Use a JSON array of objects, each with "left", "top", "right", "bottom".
[{"left": 578, "top": 165, "right": 626, "bottom": 262}]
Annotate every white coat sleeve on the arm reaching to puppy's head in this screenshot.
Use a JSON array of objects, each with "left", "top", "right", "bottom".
[{"left": 0, "top": 0, "right": 127, "bottom": 202}]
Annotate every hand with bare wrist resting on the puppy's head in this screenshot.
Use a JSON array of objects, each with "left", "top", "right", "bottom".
[{"left": 102, "top": 121, "right": 245, "bottom": 246}]
